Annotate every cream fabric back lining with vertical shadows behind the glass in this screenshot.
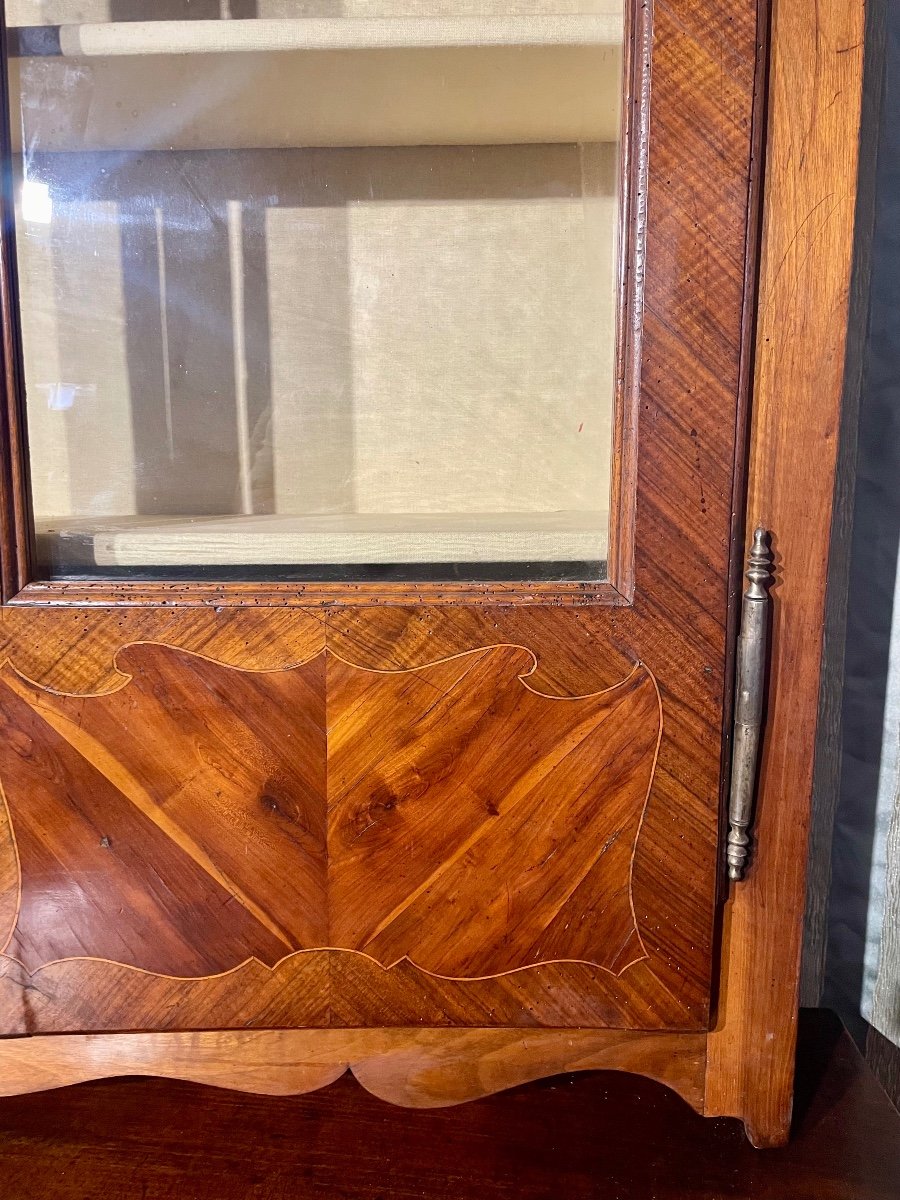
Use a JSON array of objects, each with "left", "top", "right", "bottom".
[{"left": 19, "top": 145, "right": 617, "bottom": 562}]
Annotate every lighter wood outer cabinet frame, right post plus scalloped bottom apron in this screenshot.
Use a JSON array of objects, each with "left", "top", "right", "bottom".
[{"left": 0, "top": 0, "right": 865, "bottom": 1146}]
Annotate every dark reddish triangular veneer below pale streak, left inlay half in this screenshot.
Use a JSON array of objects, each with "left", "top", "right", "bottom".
[{"left": 0, "top": 680, "right": 296, "bottom": 974}]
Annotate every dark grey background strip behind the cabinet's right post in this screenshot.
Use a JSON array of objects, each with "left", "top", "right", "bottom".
[{"left": 814, "top": 2, "right": 900, "bottom": 1089}]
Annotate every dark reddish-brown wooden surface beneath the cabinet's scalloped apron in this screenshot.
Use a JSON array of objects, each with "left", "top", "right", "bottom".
[{"left": 0, "top": 1012, "right": 900, "bottom": 1200}]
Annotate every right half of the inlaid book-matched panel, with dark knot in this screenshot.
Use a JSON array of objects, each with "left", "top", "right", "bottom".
[{"left": 328, "top": 647, "right": 660, "bottom": 978}]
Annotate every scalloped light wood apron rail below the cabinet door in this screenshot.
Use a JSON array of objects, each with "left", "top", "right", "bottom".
[{"left": 0, "top": 1028, "right": 706, "bottom": 1111}]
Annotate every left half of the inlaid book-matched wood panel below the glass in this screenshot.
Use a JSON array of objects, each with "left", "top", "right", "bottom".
[{"left": 0, "top": 647, "right": 326, "bottom": 974}]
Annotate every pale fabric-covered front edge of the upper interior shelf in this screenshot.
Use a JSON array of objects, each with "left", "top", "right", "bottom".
[{"left": 14, "top": 13, "right": 623, "bottom": 58}]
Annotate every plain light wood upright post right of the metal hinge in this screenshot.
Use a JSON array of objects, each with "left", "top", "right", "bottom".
[{"left": 707, "top": 0, "right": 864, "bottom": 1145}]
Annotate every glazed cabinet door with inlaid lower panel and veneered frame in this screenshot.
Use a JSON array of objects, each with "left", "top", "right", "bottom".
[{"left": 0, "top": 0, "right": 757, "bottom": 1036}]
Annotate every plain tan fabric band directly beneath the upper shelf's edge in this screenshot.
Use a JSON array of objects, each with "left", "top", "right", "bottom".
[{"left": 10, "top": 46, "right": 622, "bottom": 151}]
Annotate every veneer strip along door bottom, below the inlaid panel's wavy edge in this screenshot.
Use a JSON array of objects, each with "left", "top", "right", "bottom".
[{"left": 0, "top": 950, "right": 702, "bottom": 1036}]
